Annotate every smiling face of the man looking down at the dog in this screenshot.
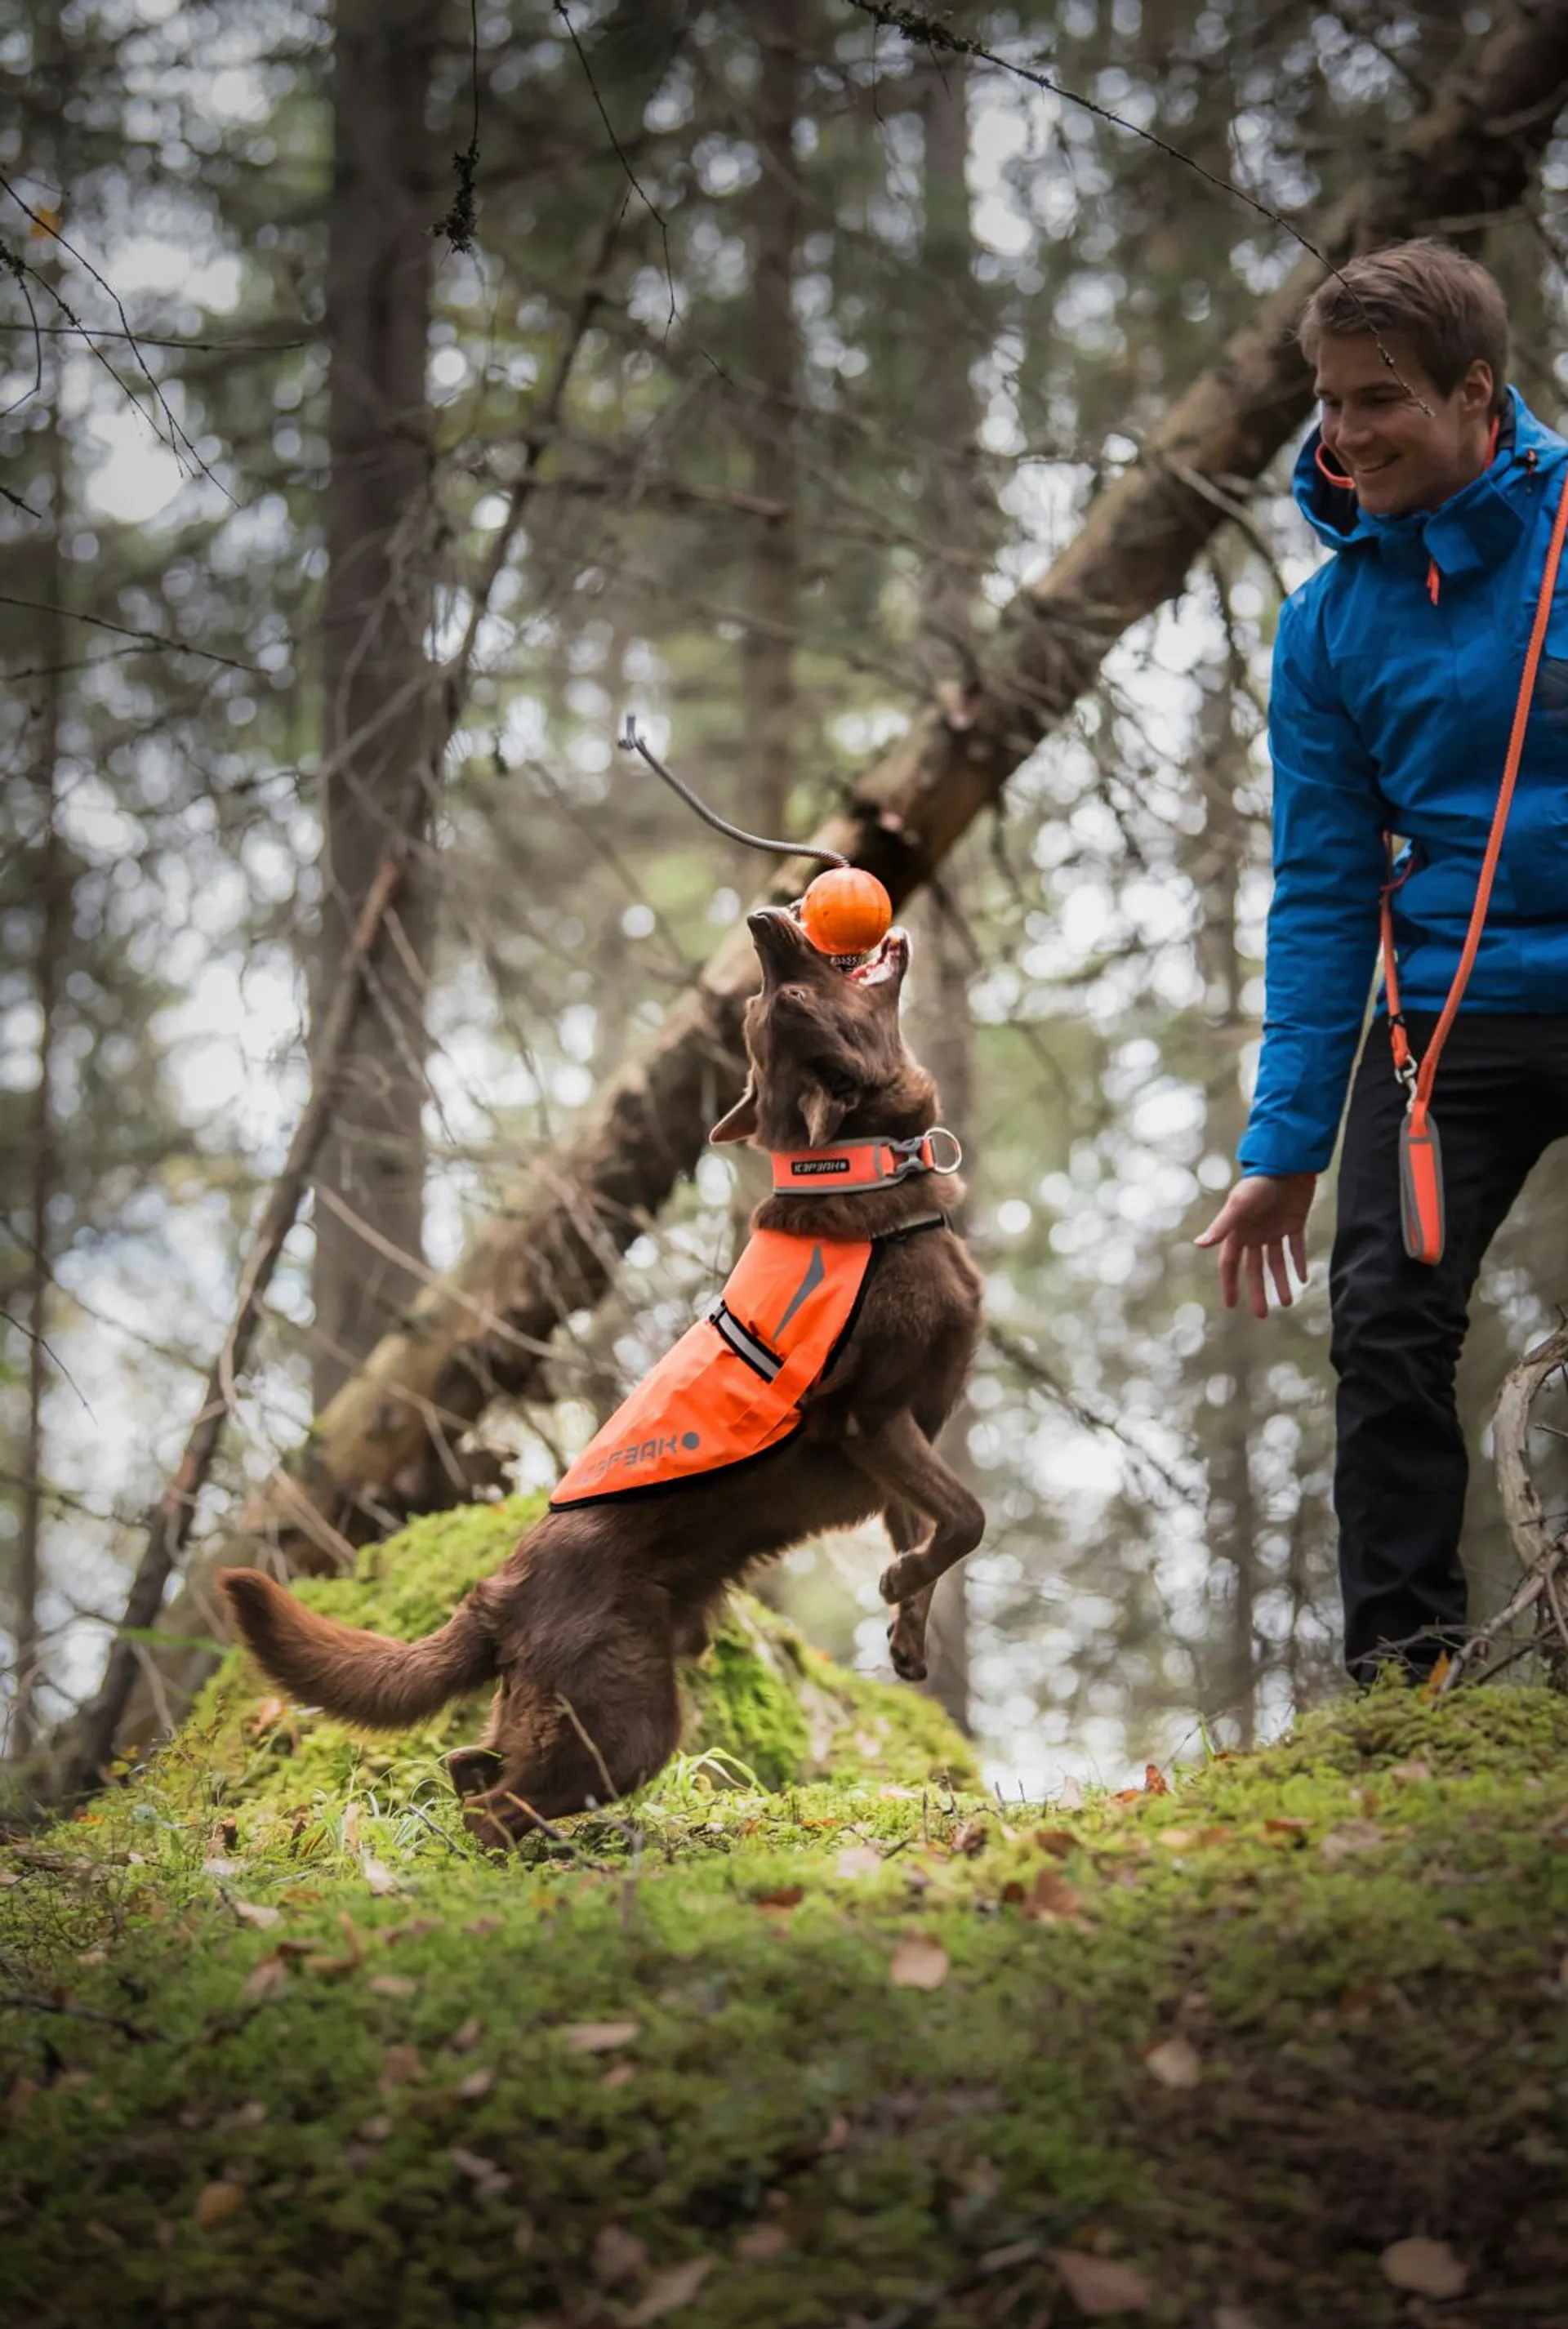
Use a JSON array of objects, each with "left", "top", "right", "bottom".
[{"left": 1314, "top": 331, "right": 1491, "bottom": 517}]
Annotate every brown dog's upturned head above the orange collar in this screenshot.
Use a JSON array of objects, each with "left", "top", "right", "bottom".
[{"left": 708, "top": 906, "right": 937, "bottom": 1151}]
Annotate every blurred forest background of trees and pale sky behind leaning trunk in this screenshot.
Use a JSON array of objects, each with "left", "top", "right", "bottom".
[{"left": 0, "top": 0, "right": 1568, "bottom": 1793}]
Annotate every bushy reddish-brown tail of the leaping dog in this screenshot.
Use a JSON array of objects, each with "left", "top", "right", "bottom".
[{"left": 219, "top": 1570, "right": 497, "bottom": 1730}]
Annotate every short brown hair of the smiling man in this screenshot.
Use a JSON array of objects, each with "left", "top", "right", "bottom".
[{"left": 1298, "top": 235, "right": 1508, "bottom": 412}]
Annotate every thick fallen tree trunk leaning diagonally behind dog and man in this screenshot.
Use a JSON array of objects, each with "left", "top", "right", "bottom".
[{"left": 113, "top": 0, "right": 1568, "bottom": 1738}]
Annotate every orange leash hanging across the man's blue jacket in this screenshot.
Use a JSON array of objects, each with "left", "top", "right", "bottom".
[{"left": 1379, "top": 475, "right": 1568, "bottom": 1262}]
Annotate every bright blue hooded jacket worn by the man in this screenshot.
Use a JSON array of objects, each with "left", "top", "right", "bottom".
[{"left": 1240, "top": 389, "right": 1568, "bottom": 1173}]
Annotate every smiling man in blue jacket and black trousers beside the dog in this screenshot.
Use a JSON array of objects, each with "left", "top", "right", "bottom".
[{"left": 1197, "top": 240, "right": 1568, "bottom": 1681}]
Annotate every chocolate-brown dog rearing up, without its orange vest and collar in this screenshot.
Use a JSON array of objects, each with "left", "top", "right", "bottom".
[{"left": 221, "top": 908, "right": 986, "bottom": 1842}]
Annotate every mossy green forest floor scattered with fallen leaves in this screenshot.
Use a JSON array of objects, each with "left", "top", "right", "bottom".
[{"left": 0, "top": 1512, "right": 1568, "bottom": 2329}]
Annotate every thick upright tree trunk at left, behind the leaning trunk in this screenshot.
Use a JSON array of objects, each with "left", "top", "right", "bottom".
[{"left": 310, "top": 0, "right": 443, "bottom": 1407}]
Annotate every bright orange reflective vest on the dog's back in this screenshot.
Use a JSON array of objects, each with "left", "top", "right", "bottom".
[{"left": 550, "top": 1225, "right": 880, "bottom": 1512}]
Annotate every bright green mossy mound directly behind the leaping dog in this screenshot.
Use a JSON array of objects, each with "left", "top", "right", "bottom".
[{"left": 158, "top": 1498, "right": 976, "bottom": 1819}]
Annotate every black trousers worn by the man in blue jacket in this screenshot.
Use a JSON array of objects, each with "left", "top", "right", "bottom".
[{"left": 1328, "top": 1011, "right": 1568, "bottom": 1681}]
